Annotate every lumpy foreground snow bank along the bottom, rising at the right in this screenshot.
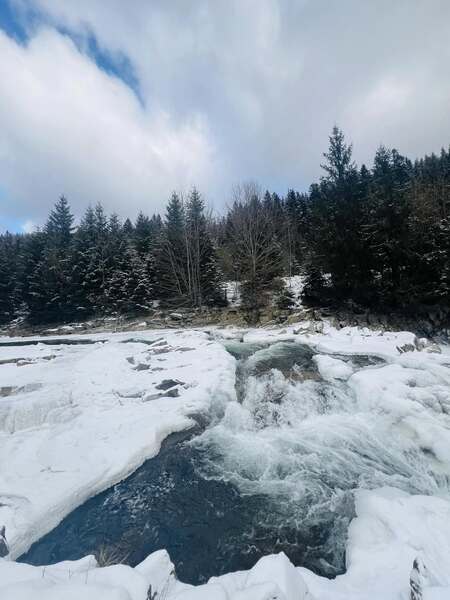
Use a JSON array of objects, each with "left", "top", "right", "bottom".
[{"left": 0, "top": 488, "right": 450, "bottom": 600}]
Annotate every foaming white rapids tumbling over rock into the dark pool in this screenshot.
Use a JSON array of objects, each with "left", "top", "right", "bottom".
[{"left": 192, "top": 343, "right": 450, "bottom": 574}]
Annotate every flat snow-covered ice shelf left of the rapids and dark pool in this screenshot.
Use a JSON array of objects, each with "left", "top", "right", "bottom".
[{"left": 0, "top": 330, "right": 235, "bottom": 557}]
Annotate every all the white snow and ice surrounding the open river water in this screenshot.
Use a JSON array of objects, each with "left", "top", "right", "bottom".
[{"left": 0, "top": 323, "right": 450, "bottom": 600}]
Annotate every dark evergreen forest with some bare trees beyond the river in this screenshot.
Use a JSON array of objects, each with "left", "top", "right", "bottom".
[{"left": 0, "top": 127, "right": 450, "bottom": 323}]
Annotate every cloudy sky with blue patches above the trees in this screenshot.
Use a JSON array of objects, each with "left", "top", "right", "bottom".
[{"left": 0, "top": 0, "right": 450, "bottom": 231}]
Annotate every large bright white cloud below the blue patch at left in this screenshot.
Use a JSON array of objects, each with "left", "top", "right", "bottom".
[{"left": 0, "top": 29, "right": 218, "bottom": 218}]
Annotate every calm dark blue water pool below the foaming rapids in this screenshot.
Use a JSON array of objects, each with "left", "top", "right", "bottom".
[{"left": 20, "top": 420, "right": 344, "bottom": 584}]
